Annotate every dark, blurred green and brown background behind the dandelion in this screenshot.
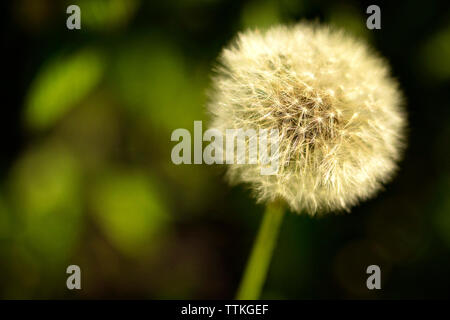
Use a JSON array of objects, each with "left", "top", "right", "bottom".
[{"left": 0, "top": 0, "right": 450, "bottom": 299}]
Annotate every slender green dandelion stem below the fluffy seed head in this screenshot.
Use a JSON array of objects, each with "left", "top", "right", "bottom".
[{"left": 236, "top": 202, "right": 284, "bottom": 300}]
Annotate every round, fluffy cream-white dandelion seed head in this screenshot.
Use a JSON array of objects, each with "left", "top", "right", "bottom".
[{"left": 209, "top": 23, "right": 406, "bottom": 214}]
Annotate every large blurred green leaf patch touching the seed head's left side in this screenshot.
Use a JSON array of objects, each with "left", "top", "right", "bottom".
[{"left": 114, "top": 37, "right": 208, "bottom": 132}]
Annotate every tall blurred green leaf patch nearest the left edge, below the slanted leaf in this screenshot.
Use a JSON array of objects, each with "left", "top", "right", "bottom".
[{"left": 11, "top": 144, "right": 81, "bottom": 268}]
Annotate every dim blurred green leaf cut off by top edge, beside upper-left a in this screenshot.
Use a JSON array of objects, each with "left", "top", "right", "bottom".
[{"left": 74, "top": 0, "right": 140, "bottom": 30}]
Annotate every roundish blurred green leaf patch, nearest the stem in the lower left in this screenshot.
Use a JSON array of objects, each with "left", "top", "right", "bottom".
[{"left": 91, "top": 171, "right": 169, "bottom": 255}]
